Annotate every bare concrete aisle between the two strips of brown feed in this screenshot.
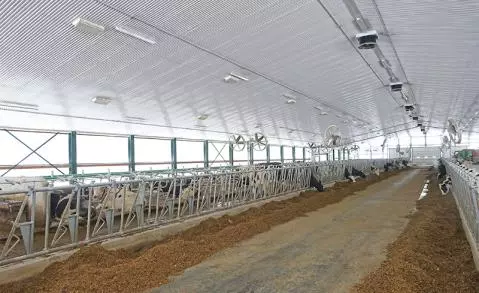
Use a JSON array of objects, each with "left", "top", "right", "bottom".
[{"left": 151, "top": 170, "right": 425, "bottom": 293}]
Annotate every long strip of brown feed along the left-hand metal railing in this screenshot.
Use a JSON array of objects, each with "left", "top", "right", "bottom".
[{"left": 0, "top": 172, "right": 404, "bottom": 293}]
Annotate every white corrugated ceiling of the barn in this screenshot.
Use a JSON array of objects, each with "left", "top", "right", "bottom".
[{"left": 0, "top": 0, "right": 479, "bottom": 143}]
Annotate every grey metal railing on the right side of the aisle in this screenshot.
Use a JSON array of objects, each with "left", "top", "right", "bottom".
[{"left": 442, "top": 159, "right": 479, "bottom": 247}]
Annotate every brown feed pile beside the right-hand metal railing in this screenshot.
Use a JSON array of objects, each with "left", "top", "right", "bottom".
[{"left": 353, "top": 176, "right": 479, "bottom": 293}]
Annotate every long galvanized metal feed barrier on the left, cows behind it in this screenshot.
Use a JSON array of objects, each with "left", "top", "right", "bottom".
[{"left": 0, "top": 160, "right": 387, "bottom": 265}]
